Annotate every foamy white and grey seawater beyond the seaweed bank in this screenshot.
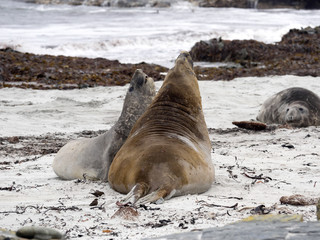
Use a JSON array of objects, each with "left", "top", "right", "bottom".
[{"left": 0, "top": 0, "right": 320, "bottom": 67}]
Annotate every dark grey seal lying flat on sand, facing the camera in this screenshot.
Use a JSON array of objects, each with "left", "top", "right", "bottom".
[{"left": 257, "top": 87, "right": 320, "bottom": 127}]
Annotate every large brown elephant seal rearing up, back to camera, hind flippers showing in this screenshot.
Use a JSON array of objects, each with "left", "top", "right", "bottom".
[{"left": 108, "top": 52, "right": 214, "bottom": 205}]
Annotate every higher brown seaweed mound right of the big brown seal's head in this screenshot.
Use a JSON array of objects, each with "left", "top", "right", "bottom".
[{"left": 190, "top": 27, "right": 320, "bottom": 80}]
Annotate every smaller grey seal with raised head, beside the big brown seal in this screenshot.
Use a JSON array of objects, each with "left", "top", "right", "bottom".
[{"left": 53, "top": 69, "right": 155, "bottom": 181}]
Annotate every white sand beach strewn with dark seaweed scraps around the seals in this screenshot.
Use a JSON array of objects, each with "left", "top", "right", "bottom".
[{"left": 0, "top": 76, "right": 320, "bottom": 239}]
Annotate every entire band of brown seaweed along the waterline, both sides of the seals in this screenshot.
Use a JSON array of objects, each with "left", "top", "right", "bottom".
[{"left": 0, "top": 27, "right": 320, "bottom": 89}]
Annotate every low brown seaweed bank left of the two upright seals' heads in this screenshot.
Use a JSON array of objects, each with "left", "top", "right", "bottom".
[{"left": 0, "top": 49, "right": 168, "bottom": 89}]
